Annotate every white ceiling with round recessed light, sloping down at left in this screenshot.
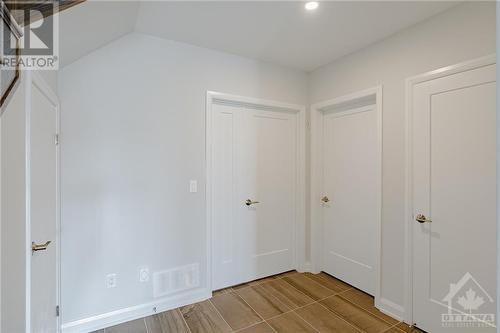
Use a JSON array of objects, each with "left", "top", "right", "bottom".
[{"left": 60, "top": 1, "right": 457, "bottom": 71}]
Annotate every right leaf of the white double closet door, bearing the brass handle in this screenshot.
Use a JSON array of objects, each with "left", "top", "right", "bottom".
[{"left": 238, "top": 109, "right": 296, "bottom": 281}]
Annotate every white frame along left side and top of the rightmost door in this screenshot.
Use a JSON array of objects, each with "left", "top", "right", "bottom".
[{"left": 404, "top": 55, "right": 496, "bottom": 324}]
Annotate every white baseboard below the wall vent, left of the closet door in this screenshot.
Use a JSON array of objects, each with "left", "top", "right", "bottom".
[{"left": 61, "top": 288, "right": 212, "bottom": 333}]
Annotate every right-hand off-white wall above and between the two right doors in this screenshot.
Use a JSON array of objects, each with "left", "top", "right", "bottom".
[{"left": 309, "top": 2, "right": 495, "bottom": 316}]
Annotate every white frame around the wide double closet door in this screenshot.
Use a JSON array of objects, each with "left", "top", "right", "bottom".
[{"left": 205, "top": 91, "right": 306, "bottom": 291}]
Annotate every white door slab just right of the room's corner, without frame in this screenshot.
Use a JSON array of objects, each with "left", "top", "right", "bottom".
[{"left": 322, "top": 105, "right": 380, "bottom": 295}]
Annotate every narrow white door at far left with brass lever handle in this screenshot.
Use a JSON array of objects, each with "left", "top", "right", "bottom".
[{"left": 30, "top": 78, "right": 59, "bottom": 333}]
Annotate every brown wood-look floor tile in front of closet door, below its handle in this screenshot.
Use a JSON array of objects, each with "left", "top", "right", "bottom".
[{"left": 236, "top": 285, "right": 291, "bottom": 319}]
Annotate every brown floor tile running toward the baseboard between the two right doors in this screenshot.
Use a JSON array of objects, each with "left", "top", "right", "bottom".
[{"left": 321, "top": 296, "right": 392, "bottom": 333}]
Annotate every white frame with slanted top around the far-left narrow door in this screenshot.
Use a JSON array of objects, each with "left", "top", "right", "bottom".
[{"left": 24, "top": 70, "right": 62, "bottom": 333}]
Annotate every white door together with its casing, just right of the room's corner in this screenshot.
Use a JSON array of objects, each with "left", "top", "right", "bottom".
[{"left": 311, "top": 87, "right": 382, "bottom": 298}]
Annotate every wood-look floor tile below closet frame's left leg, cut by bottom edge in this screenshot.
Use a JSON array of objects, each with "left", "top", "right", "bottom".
[{"left": 180, "top": 301, "right": 232, "bottom": 333}]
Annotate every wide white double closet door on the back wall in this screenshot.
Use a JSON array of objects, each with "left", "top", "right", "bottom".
[{"left": 211, "top": 104, "right": 297, "bottom": 290}]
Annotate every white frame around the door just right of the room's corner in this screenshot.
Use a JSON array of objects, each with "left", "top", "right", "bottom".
[{"left": 310, "top": 86, "right": 382, "bottom": 300}]
